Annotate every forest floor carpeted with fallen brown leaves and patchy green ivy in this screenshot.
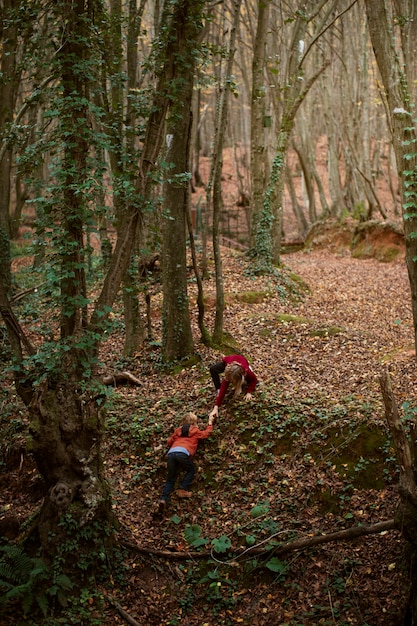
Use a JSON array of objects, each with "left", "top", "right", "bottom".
[{"left": 0, "top": 223, "right": 417, "bottom": 626}]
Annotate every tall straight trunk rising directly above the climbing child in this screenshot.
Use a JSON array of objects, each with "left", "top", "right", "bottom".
[{"left": 161, "top": 0, "right": 204, "bottom": 362}]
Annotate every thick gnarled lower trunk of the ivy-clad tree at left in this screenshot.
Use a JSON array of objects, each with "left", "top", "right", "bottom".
[{"left": 29, "top": 352, "right": 113, "bottom": 572}]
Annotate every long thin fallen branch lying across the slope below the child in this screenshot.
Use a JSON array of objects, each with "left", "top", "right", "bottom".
[{"left": 121, "top": 519, "right": 396, "bottom": 560}]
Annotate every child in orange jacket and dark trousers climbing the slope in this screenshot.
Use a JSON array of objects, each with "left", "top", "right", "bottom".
[{"left": 158, "top": 413, "right": 214, "bottom": 514}]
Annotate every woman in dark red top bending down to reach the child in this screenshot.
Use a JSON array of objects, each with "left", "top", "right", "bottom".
[{"left": 210, "top": 354, "right": 258, "bottom": 417}]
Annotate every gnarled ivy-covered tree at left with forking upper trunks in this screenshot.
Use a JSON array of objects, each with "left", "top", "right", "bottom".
[{"left": 0, "top": 0, "right": 190, "bottom": 584}]
